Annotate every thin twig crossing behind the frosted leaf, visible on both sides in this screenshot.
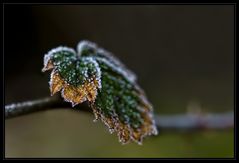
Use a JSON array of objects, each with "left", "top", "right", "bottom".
[{"left": 5, "top": 96, "right": 234, "bottom": 130}]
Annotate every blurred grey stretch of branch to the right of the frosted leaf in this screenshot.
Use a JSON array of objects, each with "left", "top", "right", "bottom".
[{"left": 155, "top": 111, "right": 234, "bottom": 130}]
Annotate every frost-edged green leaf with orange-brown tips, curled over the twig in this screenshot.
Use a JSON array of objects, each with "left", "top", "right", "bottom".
[{"left": 42, "top": 41, "right": 157, "bottom": 144}]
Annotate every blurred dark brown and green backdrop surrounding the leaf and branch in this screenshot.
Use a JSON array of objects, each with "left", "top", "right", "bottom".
[{"left": 4, "top": 5, "right": 234, "bottom": 158}]
